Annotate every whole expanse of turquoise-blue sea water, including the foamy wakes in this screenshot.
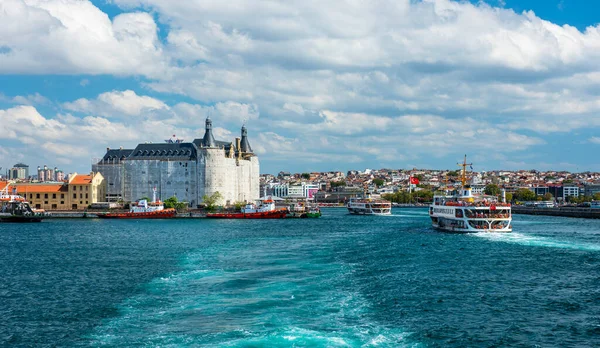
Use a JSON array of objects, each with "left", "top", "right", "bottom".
[{"left": 0, "top": 209, "right": 600, "bottom": 347}]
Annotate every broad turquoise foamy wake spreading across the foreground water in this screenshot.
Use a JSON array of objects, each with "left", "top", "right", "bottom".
[{"left": 88, "top": 246, "right": 419, "bottom": 347}]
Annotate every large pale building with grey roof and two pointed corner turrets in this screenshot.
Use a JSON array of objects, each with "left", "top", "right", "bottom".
[{"left": 92, "top": 118, "right": 260, "bottom": 207}]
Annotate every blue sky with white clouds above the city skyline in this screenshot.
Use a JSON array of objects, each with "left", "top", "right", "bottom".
[{"left": 0, "top": 0, "right": 600, "bottom": 173}]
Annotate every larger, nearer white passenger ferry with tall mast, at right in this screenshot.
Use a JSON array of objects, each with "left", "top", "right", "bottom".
[{"left": 429, "top": 156, "right": 512, "bottom": 233}]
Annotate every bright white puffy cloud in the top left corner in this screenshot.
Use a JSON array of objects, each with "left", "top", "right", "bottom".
[{"left": 0, "top": 0, "right": 166, "bottom": 76}]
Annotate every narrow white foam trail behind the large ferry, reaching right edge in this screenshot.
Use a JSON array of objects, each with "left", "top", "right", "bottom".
[{"left": 470, "top": 232, "right": 600, "bottom": 251}]
